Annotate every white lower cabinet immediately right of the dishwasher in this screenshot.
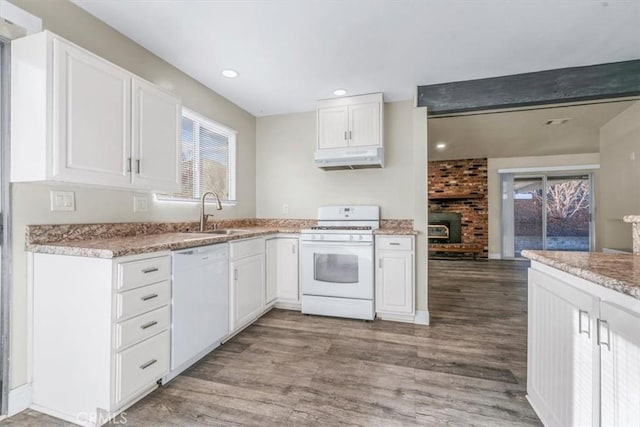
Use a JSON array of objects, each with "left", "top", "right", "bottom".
[{"left": 229, "top": 238, "right": 265, "bottom": 332}]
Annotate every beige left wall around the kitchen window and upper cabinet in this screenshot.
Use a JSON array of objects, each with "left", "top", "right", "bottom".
[{"left": 11, "top": 0, "right": 256, "bottom": 388}]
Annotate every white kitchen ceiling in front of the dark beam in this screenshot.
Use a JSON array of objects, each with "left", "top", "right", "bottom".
[{"left": 72, "top": 0, "right": 640, "bottom": 116}]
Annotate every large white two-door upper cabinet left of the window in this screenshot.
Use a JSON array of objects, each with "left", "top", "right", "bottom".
[{"left": 11, "top": 31, "right": 182, "bottom": 191}]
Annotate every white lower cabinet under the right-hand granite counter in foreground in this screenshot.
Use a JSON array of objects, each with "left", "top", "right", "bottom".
[{"left": 527, "top": 262, "right": 640, "bottom": 427}]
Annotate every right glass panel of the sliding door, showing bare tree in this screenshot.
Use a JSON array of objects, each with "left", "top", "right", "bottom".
[{"left": 545, "top": 175, "right": 591, "bottom": 251}]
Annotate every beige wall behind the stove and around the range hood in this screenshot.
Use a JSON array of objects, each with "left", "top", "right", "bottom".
[{"left": 256, "top": 101, "right": 427, "bottom": 310}]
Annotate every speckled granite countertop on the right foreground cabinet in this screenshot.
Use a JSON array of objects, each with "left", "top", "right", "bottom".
[{"left": 522, "top": 251, "right": 640, "bottom": 299}]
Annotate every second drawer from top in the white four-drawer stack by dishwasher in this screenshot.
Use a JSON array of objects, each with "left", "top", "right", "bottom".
[{"left": 116, "top": 280, "right": 171, "bottom": 319}]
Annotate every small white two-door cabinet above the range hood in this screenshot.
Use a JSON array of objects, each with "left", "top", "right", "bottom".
[{"left": 317, "top": 93, "right": 383, "bottom": 151}]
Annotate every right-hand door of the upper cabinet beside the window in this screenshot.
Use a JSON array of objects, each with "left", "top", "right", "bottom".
[{"left": 131, "top": 79, "right": 182, "bottom": 191}]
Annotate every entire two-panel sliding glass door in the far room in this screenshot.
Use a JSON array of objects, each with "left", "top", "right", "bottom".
[{"left": 502, "top": 174, "right": 593, "bottom": 258}]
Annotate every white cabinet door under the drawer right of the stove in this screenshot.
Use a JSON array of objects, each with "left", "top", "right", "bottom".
[{"left": 376, "top": 251, "right": 414, "bottom": 315}]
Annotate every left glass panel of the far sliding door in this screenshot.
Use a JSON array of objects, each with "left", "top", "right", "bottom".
[{"left": 513, "top": 177, "right": 545, "bottom": 257}]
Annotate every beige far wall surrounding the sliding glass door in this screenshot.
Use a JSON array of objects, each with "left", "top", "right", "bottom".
[{"left": 487, "top": 153, "right": 600, "bottom": 258}]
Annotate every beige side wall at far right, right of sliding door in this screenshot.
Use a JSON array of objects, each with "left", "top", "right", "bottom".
[{"left": 596, "top": 101, "right": 640, "bottom": 249}]
